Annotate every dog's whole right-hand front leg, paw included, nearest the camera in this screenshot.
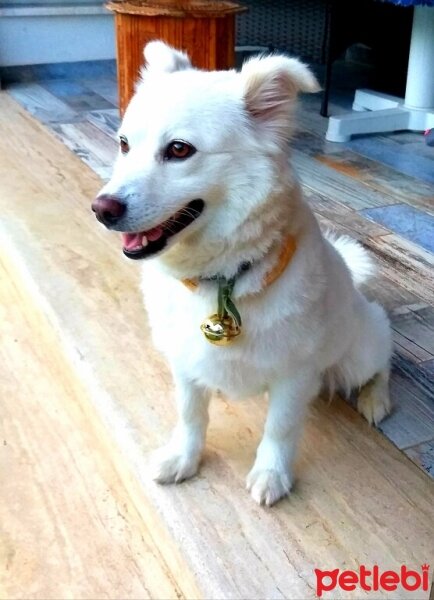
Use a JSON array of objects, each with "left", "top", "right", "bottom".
[{"left": 247, "top": 369, "right": 321, "bottom": 506}]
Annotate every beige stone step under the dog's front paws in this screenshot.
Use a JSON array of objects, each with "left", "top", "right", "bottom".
[{"left": 0, "top": 94, "right": 434, "bottom": 599}]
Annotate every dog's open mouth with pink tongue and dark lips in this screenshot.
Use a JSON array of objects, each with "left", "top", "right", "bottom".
[{"left": 122, "top": 199, "right": 205, "bottom": 260}]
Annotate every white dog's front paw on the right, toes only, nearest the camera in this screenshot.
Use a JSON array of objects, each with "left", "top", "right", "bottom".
[{"left": 246, "top": 467, "right": 292, "bottom": 506}]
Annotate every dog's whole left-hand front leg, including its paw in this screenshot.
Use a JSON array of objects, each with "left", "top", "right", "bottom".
[{"left": 152, "top": 376, "right": 210, "bottom": 483}]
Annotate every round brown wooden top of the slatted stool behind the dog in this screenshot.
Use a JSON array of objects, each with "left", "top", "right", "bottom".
[{"left": 106, "top": 0, "right": 247, "bottom": 18}]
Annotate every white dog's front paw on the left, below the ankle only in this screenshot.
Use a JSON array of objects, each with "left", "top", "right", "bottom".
[{"left": 152, "top": 446, "right": 200, "bottom": 483}]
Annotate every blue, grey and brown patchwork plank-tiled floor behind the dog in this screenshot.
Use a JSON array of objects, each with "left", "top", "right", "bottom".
[{"left": 8, "top": 56, "right": 434, "bottom": 477}]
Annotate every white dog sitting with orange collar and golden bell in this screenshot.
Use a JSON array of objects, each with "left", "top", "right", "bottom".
[{"left": 93, "top": 42, "right": 391, "bottom": 505}]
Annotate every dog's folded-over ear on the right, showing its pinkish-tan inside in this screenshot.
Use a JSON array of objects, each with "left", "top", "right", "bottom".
[{"left": 241, "top": 55, "right": 320, "bottom": 145}]
